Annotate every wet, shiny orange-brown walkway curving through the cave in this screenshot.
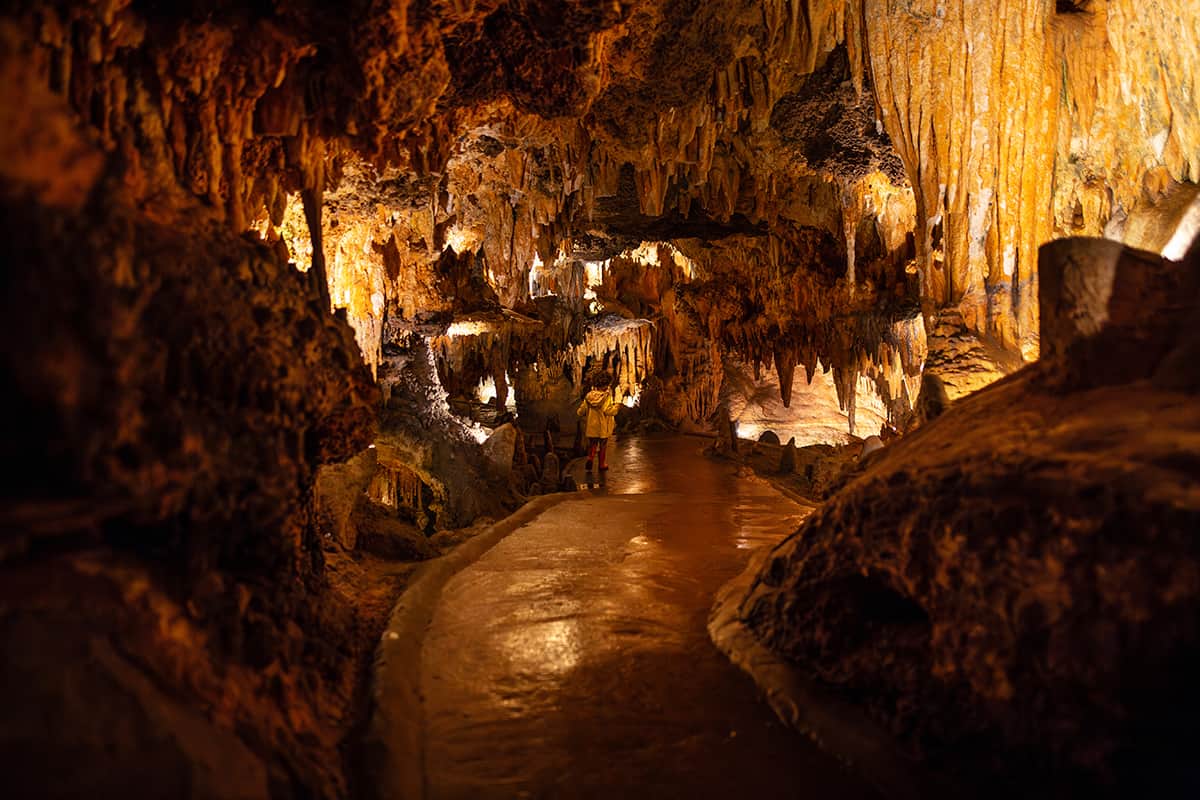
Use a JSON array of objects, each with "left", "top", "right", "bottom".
[{"left": 421, "top": 437, "right": 876, "bottom": 799}]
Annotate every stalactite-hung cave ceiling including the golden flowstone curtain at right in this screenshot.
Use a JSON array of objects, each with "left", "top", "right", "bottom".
[{"left": 11, "top": 0, "right": 1200, "bottom": 412}]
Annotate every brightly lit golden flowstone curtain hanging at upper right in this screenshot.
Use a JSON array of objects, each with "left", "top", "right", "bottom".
[{"left": 862, "top": 0, "right": 1200, "bottom": 359}]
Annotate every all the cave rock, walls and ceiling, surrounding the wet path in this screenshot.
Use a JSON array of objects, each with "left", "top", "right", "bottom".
[{"left": 0, "top": 0, "right": 1200, "bottom": 798}]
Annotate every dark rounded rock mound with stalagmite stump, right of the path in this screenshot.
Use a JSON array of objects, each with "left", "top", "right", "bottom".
[{"left": 740, "top": 240, "right": 1200, "bottom": 796}]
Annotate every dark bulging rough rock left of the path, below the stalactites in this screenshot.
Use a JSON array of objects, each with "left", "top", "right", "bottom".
[{"left": 0, "top": 164, "right": 377, "bottom": 796}]
